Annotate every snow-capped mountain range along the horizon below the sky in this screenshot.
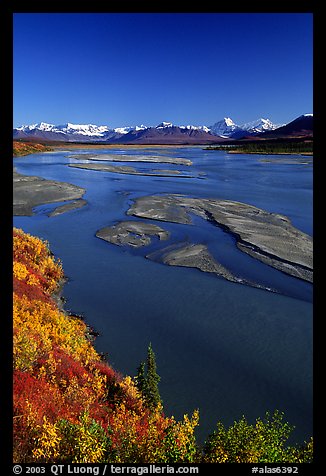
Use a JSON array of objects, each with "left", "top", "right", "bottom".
[{"left": 13, "top": 114, "right": 313, "bottom": 144}]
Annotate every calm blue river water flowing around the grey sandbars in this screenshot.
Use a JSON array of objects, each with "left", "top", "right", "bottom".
[{"left": 14, "top": 147, "right": 312, "bottom": 442}]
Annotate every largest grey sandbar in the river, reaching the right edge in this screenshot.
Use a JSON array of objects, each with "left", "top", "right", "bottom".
[{"left": 127, "top": 194, "right": 313, "bottom": 282}]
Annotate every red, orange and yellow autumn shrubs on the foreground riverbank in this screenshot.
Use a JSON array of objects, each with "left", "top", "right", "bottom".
[{"left": 13, "top": 228, "right": 312, "bottom": 463}]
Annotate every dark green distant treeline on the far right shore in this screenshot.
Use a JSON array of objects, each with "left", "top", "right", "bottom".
[{"left": 205, "top": 140, "right": 313, "bottom": 154}]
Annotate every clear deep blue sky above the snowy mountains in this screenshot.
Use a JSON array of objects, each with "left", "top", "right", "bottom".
[{"left": 13, "top": 13, "right": 313, "bottom": 127}]
